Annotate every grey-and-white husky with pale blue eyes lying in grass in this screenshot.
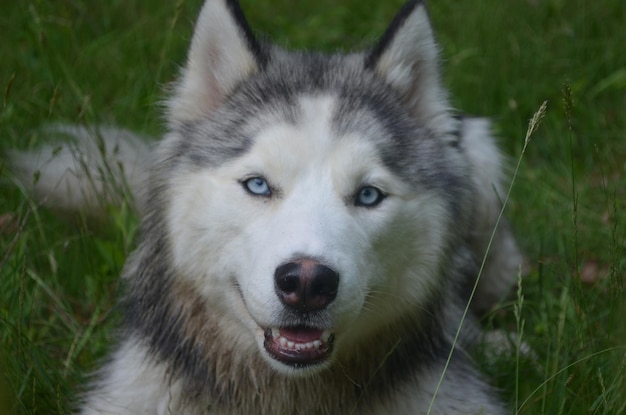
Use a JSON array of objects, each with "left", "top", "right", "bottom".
[{"left": 16, "top": 0, "right": 521, "bottom": 415}]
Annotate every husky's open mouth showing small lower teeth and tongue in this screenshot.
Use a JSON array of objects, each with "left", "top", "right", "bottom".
[{"left": 263, "top": 326, "right": 335, "bottom": 368}]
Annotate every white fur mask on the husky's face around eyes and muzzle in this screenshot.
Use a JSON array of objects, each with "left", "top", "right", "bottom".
[{"left": 169, "top": 96, "right": 446, "bottom": 366}]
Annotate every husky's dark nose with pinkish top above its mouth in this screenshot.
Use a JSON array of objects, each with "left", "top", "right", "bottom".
[{"left": 274, "top": 259, "right": 339, "bottom": 311}]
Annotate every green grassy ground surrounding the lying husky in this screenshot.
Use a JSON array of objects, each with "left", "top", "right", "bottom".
[{"left": 0, "top": 0, "right": 626, "bottom": 415}]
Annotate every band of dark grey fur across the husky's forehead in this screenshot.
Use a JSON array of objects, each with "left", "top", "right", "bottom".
[{"left": 168, "top": 50, "right": 459, "bottom": 193}]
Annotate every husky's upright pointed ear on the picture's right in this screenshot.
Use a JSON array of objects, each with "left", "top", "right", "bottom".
[{"left": 365, "top": 0, "right": 449, "bottom": 130}]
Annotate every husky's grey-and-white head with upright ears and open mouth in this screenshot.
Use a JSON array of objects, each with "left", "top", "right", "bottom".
[{"left": 159, "top": 0, "right": 468, "bottom": 373}]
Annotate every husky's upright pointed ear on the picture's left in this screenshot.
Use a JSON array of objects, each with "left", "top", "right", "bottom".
[{"left": 167, "top": 0, "right": 267, "bottom": 123}]
